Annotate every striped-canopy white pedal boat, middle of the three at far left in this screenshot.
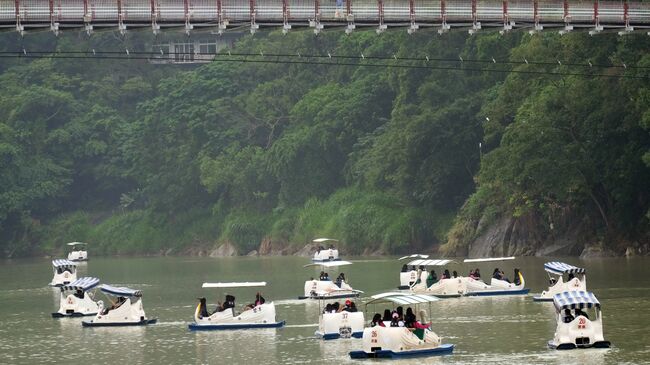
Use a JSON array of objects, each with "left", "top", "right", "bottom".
[{"left": 52, "top": 277, "right": 99, "bottom": 318}]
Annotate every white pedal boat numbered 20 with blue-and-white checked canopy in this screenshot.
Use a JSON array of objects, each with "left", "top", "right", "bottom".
[{"left": 548, "top": 291, "right": 611, "bottom": 350}]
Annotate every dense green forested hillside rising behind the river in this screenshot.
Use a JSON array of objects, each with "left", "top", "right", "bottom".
[{"left": 0, "top": 31, "right": 650, "bottom": 256}]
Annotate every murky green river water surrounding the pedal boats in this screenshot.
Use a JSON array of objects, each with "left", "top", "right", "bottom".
[{"left": 0, "top": 252, "right": 650, "bottom": 365}]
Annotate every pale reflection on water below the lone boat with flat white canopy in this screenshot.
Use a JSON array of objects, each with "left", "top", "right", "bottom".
[{"left": 188, "top": 328, "right": 282, "bottom": 364}]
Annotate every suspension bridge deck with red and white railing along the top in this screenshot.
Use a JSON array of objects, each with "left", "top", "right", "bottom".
[{"left": 0, "top": 0, "right": 650, "bottom": 34}]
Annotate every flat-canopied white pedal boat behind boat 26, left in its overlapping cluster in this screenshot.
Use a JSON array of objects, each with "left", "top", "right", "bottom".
[{"left": 400, "top": 259, "right": 465, "bottom": 298}]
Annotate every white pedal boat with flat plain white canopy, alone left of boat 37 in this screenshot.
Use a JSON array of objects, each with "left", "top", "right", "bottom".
[{"left": 189, "top": 281, "right": 285, "bottom": 331}]
